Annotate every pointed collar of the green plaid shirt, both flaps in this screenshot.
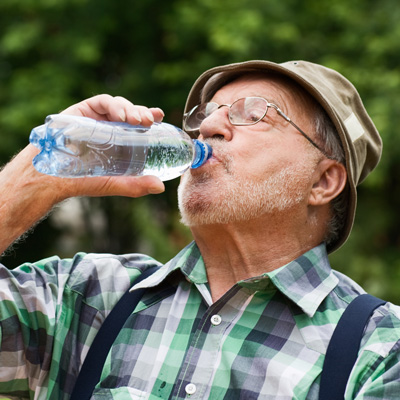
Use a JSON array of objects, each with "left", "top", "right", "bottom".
[{"left": 131, "top": 242, "right": 339, "bottom": 317}]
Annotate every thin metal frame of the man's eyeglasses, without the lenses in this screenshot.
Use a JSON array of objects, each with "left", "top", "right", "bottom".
[{"left": 183, "top": 96, "right": 332, "bottom": 159}]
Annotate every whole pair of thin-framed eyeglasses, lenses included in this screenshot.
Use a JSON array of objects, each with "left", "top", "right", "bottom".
[{"left": 183, "top": 97, "right": 331, "bottom": 158}]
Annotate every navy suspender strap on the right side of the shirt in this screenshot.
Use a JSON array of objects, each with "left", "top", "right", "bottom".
[{"left": 319, "top": 294, "right": 386, "bottom": 400}]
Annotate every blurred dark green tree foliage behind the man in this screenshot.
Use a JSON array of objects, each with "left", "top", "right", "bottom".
[{"left": 0, "top": 0, "right": 400, "bottom": 303}]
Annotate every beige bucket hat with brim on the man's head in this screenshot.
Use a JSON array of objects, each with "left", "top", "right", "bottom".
[{"left": 185, "top": 60, "right": 382, "bottom": 252}]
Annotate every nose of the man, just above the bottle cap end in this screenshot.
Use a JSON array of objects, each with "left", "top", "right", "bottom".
[{"left": 199, "top": 105, "right": 233, "bottom": 140}]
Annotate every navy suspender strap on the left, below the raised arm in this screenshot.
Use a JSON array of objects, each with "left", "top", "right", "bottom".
[{"left": 71, "top": 266, "right": 159, "bottom": 400}]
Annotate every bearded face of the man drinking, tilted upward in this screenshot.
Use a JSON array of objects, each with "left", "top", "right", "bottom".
[{"left": 178, "top": 76, "right": 321, "bottom": 227}]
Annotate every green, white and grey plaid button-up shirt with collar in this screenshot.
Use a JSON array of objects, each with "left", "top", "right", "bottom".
[{"left": 0, "top": 243, "right": 400, "bottom": 400}]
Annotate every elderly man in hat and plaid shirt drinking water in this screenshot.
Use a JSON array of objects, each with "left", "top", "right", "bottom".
[{"left": 0, "top": 61, "right": 400, "bottom": 400}]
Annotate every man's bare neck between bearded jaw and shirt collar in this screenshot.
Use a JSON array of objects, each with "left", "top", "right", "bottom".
[{"left": 192, "top": 209, "right": 321, "bottom": 301}]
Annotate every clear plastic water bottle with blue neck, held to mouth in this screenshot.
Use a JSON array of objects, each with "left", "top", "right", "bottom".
[{"left": 29, "top": 114, "right": 212, "bottom": 181}]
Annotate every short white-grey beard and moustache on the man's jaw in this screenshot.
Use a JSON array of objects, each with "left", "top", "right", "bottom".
[{"left": 178, "top": 142, "right": 315, "bottom": 226}]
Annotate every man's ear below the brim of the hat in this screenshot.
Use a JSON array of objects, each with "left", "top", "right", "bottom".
[{"left": 308, "top": 159, "right": 347, "bottom": 206}]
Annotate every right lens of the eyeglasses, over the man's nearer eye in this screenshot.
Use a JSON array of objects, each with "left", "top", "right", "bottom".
[{"left": 229, "top": 97, "right": 268, "bottom": 125}]
